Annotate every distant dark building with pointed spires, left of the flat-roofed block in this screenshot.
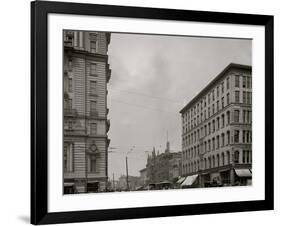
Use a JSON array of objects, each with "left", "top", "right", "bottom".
[{"left": 146, "top": 141, "right": 181, "bottom": 184}]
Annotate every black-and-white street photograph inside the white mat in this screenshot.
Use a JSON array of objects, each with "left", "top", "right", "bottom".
[{"left": 62, "top": 30, "right": 254, "bottom": 194}]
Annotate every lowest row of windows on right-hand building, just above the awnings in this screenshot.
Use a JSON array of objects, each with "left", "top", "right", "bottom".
[{"left": 183, "top": 150, "right": 252, "bottom": 174}]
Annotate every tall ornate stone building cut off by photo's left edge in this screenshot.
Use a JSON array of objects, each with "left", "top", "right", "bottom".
[{"left": 63, "top": 30, "right": 111, "bottom": 193}]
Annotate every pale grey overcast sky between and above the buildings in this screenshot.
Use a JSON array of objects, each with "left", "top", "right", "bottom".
[{"left": 108, "top": 33, "right": 252, "bottom": 179}]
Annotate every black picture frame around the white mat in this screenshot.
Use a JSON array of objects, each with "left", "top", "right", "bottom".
[{"left": 31, "top": 1, "right": 274, "bottom": 224}]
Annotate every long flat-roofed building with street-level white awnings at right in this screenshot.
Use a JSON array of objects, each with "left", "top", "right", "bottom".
[{"left": 180, "top": 64, "right": 252, "bottom": 187}]
